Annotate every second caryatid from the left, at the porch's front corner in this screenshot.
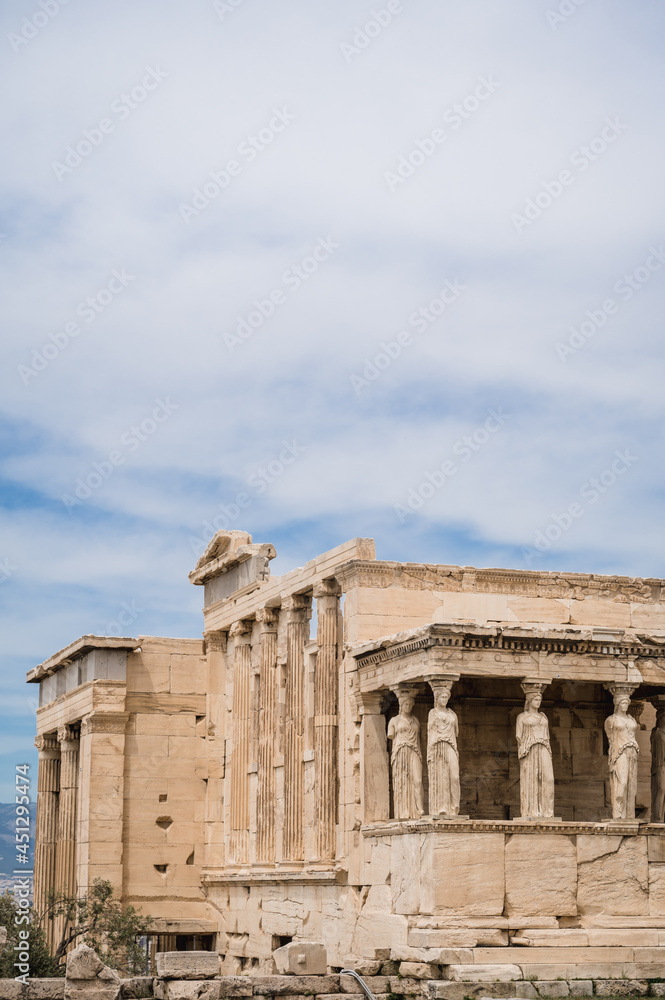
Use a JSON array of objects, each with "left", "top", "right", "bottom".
[{"left": 427, "top": 677, "right": 460, "bottom": 816}]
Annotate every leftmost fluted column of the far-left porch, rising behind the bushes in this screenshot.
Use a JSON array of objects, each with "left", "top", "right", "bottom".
[{"left": 34, "top": 733, "right": 60, "bottom": 945}]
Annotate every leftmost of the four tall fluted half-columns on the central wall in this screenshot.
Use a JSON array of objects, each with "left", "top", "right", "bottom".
[{"left": 229, "top": 621, "right": 252, "bottom": 864}]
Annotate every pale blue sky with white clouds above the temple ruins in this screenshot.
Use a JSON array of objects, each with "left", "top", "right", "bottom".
[{"left": 0, "top": 0, "right": 665, "bottom": 801}]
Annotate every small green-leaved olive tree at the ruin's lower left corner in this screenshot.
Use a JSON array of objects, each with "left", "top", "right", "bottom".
[{"left": 41, "top": 878, "right": 152, "bottom": 975}]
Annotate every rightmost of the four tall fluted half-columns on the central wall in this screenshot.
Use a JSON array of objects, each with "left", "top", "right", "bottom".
[{"left": 314, "top": 580, "right": 342, "bottom": 861}]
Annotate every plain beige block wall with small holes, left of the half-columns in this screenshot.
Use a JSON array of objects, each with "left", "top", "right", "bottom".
[{"left": 122, "top": 638, "right": 206, "bottom": 918}]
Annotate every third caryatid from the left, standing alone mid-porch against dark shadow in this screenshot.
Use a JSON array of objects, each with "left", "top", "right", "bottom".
[{"left": 516, "top": 680, "right": 554, "bottom": 819}]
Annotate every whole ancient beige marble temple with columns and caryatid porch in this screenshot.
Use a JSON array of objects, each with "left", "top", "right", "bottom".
[{"left": 28, "top": 531, "right": 665, "bottom": 980}]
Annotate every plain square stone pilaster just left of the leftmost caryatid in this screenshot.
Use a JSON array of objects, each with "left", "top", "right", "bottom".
[{"left": 360, "top": 691, "right": 390, "bottom": 823}]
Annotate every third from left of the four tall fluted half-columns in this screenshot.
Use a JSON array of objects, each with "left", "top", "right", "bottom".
[{"left": 282, "top": 594, "right": 310, "bottom": 861}]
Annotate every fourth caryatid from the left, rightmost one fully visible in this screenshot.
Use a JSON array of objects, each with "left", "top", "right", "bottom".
[{"left": 605, "top": 684, "right": 640, "bottom": 819}]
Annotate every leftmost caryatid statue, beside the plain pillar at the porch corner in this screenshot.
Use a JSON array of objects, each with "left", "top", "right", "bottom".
[{"left": 388, "top": 684, "right": 425, "bottom": 819}]
